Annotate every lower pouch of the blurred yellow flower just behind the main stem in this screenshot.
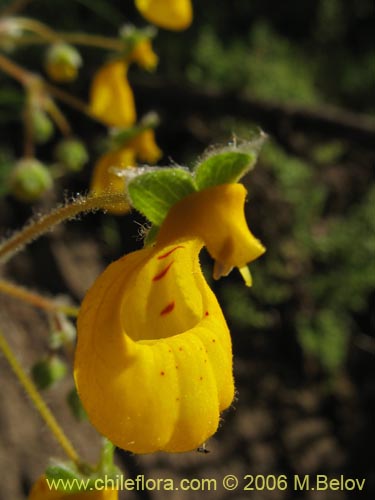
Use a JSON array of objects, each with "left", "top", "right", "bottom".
[{"left": 90, "top": 148, "right": 135, "bottom": 215}]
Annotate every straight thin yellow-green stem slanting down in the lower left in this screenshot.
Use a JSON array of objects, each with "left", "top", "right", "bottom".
[{"left": 0, "top": 331, "right": 81, "bottom": 467}]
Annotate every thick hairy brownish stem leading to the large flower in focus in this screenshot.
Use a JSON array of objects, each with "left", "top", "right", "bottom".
[{"left": 0, "top": 193, "right": 128, "bottom": 264}]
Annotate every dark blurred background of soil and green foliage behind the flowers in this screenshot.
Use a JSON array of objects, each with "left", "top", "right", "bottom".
[{"left": 0, "top": 0, "right": 375, "bottom": 500}]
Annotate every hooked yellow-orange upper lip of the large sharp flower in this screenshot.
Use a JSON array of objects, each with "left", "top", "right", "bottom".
[{"left": 158, "top": 184, "right": 265, "bottom": 279}]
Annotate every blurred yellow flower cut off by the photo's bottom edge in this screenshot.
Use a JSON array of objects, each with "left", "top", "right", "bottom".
[{"left": 28, "top": 476, "right": 118, "bottom": 500}]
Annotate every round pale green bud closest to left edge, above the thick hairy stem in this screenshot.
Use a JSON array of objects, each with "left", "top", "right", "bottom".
[{"left": 9, "top": 158, "right": 52, "bottom": 203}]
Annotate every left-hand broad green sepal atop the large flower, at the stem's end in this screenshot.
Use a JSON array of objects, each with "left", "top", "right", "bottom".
[{"left": 128, "top": 168, "right": 196, "bottom": 226}]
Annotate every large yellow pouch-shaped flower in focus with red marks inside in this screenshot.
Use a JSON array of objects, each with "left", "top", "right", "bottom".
[{"left": 74, "top": 184, "right": 264, "bottom": 453}]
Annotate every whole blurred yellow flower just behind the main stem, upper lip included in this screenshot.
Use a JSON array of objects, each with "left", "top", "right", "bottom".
[{"left": 90, "top": 129, "right": 162, "bottom": 215}]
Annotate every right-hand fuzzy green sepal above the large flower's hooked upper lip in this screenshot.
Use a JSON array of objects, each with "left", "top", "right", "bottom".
[{"left": 195, "top": 151, "right": 257, "bottom": 190}]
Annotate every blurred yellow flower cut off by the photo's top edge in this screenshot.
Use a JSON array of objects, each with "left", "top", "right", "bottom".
[{"left": 135, "top": 0, "right": 193, "bottom": 31}]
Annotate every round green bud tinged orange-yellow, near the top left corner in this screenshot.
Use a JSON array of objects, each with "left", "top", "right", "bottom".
[{"left": 45, "top": 42, "right": 82, "bottom": 83}]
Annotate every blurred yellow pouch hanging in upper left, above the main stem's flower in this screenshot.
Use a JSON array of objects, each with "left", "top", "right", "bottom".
[{"left": 90, "top": 60, "right": 136, "bottom": 127}]
